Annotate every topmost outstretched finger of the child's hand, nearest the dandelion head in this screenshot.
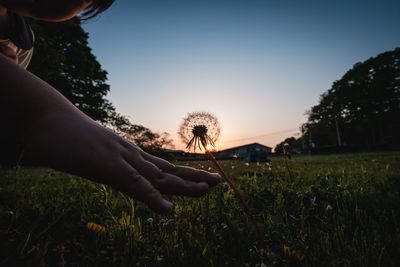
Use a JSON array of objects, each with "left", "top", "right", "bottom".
[{"left": 141, "top": 152, "right": 221, "bottom": 186}]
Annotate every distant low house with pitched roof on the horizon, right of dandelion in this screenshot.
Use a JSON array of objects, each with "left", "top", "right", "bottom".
[{"left": 215, "top": 143, "right": 272, "bottom": 163}]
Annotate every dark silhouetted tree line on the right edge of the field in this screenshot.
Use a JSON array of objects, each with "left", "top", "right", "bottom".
[{"left": 275, "top": 48, "right": 400, "bottom": 153}]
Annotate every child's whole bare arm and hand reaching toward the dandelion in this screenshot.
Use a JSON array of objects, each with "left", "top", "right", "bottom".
[{"left": 0, "top": 54, "right": 220, "bottom": 213}]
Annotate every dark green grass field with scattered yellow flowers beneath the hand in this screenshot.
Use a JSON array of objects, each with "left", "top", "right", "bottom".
[{"left": 0, "top": 152, "right": 400, "bottom": 266}]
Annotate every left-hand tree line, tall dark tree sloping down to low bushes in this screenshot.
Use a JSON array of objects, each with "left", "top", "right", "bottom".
[{"left": 28, "top": 21, "right": 173, "bottom": 152}]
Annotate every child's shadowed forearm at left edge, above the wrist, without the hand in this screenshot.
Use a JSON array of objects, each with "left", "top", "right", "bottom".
[{"left": 0, "top": 54, "right": 84, "bottom": 141}]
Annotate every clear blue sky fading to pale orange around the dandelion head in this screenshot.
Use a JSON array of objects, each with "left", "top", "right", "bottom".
[{"left": 83, "top": 0, "right": 400, "bottom": 149}]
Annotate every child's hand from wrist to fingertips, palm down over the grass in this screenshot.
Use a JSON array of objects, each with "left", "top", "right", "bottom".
[{"left": 23, "top": 110, "right": 220, "bottom": 213}]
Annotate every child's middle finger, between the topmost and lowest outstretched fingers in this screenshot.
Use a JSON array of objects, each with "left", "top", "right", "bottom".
[{"left": 124, "top": 153, "right": 208, "bottom": 197}]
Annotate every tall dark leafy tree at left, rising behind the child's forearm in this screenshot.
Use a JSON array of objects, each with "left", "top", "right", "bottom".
[{"left": 29, "top": 21, "right": 115, "bottom": 123}]
